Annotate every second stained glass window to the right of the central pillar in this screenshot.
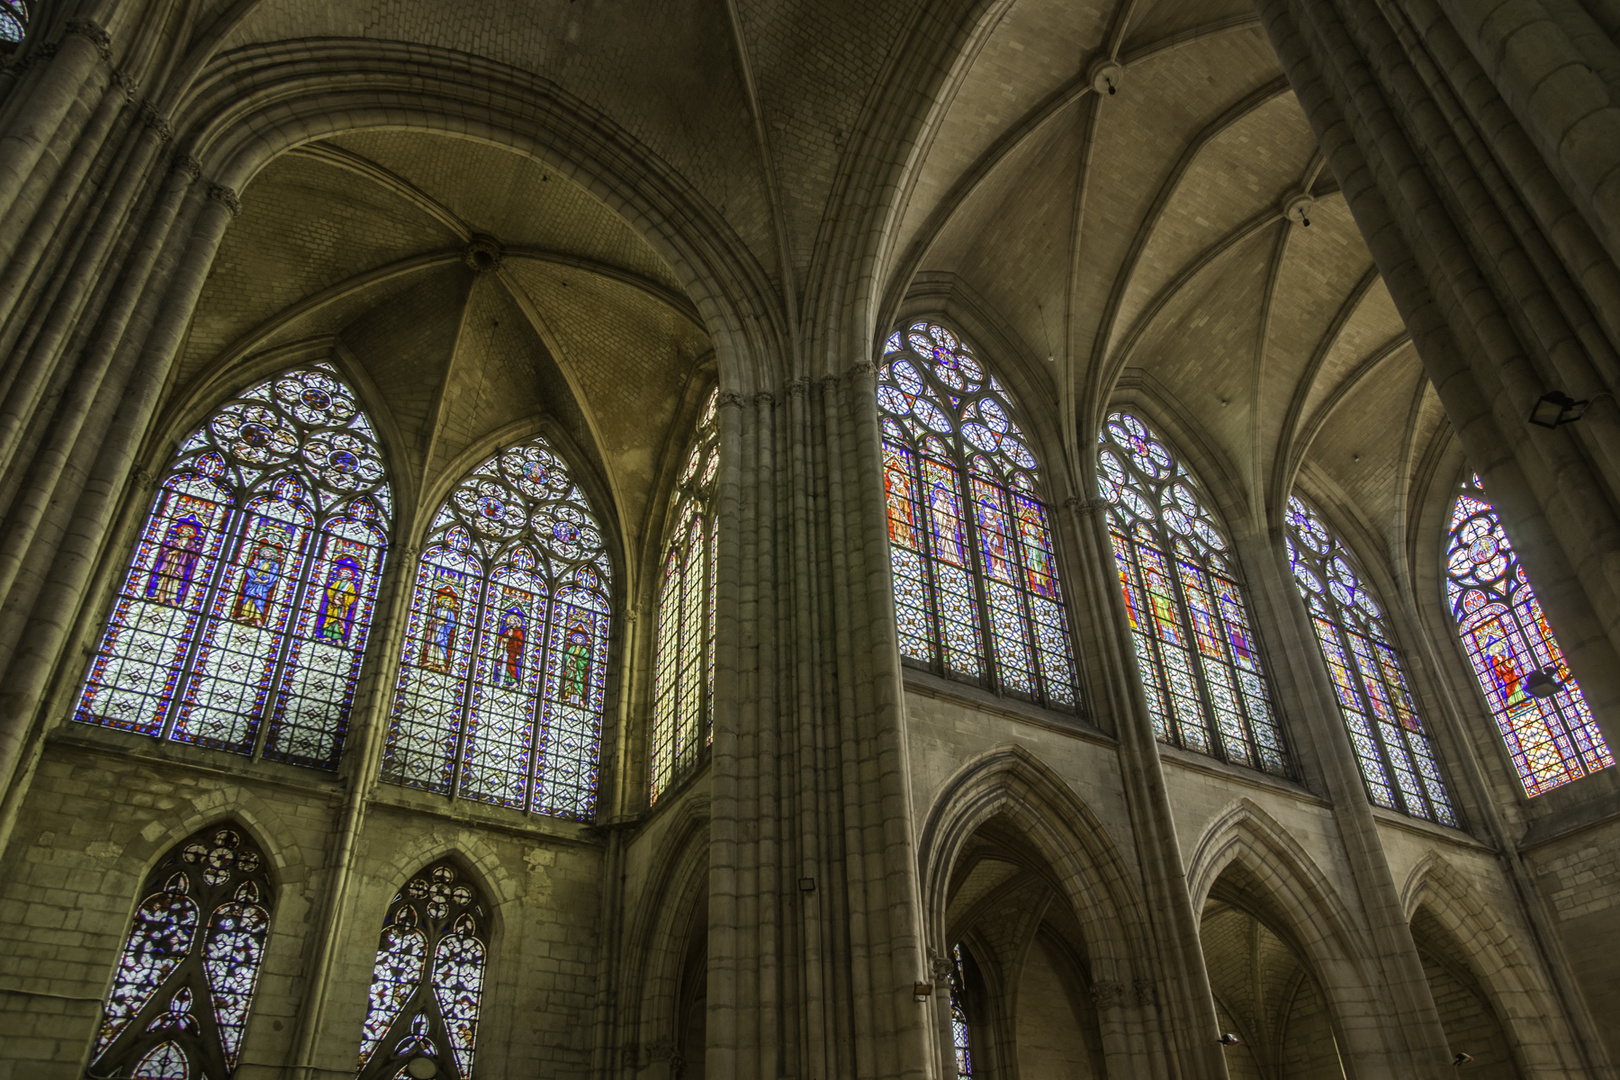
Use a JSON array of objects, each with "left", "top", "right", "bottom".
[{"left": 1097, "top": 413, "right": 1290, "bottom": 776}]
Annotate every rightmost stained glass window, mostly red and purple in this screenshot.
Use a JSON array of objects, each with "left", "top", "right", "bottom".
[{"left": 1447, "top": 476, "right": 1615, "bottom": 795}]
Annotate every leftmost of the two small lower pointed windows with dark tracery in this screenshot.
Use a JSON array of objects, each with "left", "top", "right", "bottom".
[{"left": 89, "top": 826, "right": 274, "bottom": 1080}]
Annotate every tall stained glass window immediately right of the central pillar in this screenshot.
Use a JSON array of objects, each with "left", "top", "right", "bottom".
[{"left": 878, "top": 322, "right": 1077, "bottom": 711}]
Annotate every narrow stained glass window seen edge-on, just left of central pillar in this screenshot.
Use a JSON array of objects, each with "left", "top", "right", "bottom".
[{"left": 650, "top": 390, "right": 719, "bottom": 803}]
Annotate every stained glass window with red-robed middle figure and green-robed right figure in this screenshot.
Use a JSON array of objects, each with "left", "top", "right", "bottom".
[{"left": 382, "top": 437, "right": 611, "bottom": 821}]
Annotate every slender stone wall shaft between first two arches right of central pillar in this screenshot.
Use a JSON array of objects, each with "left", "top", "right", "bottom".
[{"left": 1066, "top": 499, "right": 1226, "bottom": 1080}]
